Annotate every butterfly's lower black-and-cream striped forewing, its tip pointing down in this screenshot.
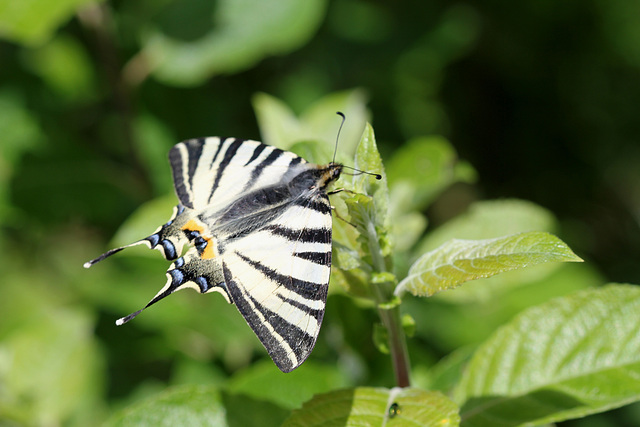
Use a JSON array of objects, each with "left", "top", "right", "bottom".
[{"left": 222, "top": 192, "right": 331, "bottom": 372}]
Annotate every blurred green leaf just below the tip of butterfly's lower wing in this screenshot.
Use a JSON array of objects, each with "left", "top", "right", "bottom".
[{"left": 227, "top": 360, "right": 347, "bottom": 409}]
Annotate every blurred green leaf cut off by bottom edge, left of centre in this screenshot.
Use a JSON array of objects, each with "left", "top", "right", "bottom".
[{"left": 105, "top": 385, "right": 228, "bottom": 427}]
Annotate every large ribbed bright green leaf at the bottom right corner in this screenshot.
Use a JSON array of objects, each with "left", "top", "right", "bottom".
[{"left": 455, "top": 285, "right": 640, "bottom": 427}]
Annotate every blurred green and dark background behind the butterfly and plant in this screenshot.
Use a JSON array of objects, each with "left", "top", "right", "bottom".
[{"left": 0, "top": 0, "right": 640, "bottom": 426}]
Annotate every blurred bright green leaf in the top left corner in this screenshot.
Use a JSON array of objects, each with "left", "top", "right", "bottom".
[{"left": 0, "top": 0, "right": 93, "bottom": 46}]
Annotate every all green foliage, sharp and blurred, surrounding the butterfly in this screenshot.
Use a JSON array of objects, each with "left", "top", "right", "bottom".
[{"left": 0, "top": 0, "right": 640, "bottom": 427}]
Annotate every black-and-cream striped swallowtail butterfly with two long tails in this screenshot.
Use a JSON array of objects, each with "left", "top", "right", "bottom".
[{"left": 84, "top": 137, "right": 343, "bottom": 372}]
